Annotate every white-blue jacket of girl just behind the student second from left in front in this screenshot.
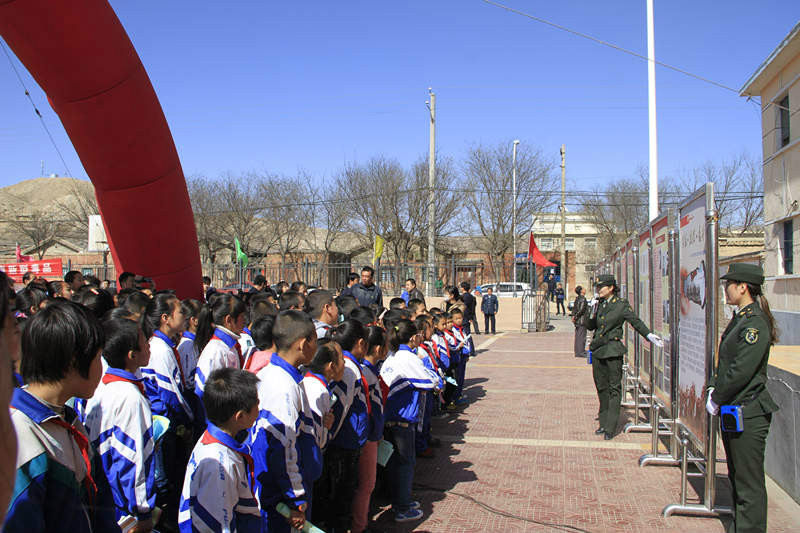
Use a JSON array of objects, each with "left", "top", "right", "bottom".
[{"left": 139, "top": 330, "right": 194, "bottom": 427}]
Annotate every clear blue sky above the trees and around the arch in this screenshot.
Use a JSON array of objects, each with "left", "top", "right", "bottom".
[{"left": 0, "top": 0, "right": 800, "bottom": 203}]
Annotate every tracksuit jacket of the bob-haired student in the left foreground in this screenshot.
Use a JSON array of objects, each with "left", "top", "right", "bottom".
[{"left": 2, "top": 388, "right": 119, "bottom": 533}]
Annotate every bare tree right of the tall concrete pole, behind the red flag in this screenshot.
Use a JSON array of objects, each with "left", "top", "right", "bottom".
[{"left": 463, "top": 141, "right": 556, "bottom": 281}]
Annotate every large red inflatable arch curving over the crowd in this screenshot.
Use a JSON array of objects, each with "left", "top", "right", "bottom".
[{"left": 0, "top": 0, "right": 202, "bottom": 298}]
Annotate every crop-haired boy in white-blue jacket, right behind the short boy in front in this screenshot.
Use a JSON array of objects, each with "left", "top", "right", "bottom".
[{"left": 250, "top": 310, "right": 317, "bottom": 533}]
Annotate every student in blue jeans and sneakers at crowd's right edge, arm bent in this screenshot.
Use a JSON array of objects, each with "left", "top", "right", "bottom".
[{"left": 381, "top": 319, "right": 439, "bottom": 522}]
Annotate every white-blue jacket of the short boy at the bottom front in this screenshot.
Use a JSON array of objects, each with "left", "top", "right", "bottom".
[{"left": 178, "top": 422, "right": 262, "bottom": 533}]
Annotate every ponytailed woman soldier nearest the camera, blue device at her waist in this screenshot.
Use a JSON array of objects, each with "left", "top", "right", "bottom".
[{"left": 706, "top": 263, "right": 778, "bottom": 533}]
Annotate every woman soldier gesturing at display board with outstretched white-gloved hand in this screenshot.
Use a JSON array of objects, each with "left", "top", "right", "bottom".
[{"left": 587, "top": 275, "right": 663, "bottom": 440}]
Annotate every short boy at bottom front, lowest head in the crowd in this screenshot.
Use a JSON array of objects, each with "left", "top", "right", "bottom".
[{"left": 179, "top": 368, "right": 262, "bottom": 533}]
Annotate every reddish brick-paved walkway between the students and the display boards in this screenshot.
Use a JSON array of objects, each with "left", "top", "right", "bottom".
[{"left": 368, "top": 319, "right": 800, "bottom": 533}]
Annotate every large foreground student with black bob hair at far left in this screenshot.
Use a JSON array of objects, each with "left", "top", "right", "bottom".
[{"left": 3, "top": 300, "right": 119, "bottom": 533}]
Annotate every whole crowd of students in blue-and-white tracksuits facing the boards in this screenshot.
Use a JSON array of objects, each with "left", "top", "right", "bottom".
[{"left": 0, "top": 267, "right": 474, "bottom": 533}]
